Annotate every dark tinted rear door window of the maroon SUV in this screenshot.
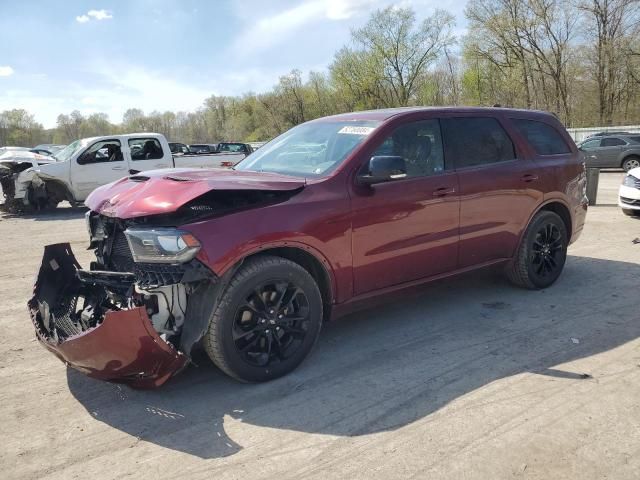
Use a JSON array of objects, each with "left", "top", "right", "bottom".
[{"left": 443, "top": 117, "right": 516, "bottom": 168}]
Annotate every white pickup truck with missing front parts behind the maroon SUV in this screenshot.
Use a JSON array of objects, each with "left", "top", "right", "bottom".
[{"left": 5, "top": 133, "right": 246, "bottom": 209}]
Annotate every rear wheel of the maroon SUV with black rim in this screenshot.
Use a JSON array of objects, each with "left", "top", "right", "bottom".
[{"left": 506, "top": 210, "right": 569, "bottom": 290}]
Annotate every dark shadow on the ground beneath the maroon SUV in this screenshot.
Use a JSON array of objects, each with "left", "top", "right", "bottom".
[{"left": 67, "top": 256, "right": 640, "bottom": 458}]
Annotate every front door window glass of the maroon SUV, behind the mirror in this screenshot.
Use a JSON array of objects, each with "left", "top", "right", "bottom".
[{"left": 372, "top": 120, "right": 444, "bottom": 178}]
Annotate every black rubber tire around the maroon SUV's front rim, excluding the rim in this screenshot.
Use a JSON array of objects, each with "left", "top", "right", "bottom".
[{"left": 212, "top": 260, "right": 322, "bottom": 382}]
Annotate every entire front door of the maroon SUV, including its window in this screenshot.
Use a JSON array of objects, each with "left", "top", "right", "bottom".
[{"left": 351, "top": 119, "right": 460, "bottom": 295}]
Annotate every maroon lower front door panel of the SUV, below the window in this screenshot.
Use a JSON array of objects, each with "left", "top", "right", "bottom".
[{"left": 351, "top": 172, "right": 460, "bottom": 295}]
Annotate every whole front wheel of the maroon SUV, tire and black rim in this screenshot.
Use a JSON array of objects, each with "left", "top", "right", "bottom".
[{"left": 204, "top": 256, "right": 322, "bottom": 382}]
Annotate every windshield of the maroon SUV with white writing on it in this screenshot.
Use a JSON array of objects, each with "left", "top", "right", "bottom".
[{"left": 236, "top": 121, "right": 380, "bottom": 177}]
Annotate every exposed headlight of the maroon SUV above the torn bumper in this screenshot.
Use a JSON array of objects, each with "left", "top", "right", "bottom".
[{"left": 124, "top": 228, "right": 200, "bottom": 263}]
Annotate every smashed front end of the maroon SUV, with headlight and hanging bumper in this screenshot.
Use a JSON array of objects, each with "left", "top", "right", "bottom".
[{"left": 28, "top": 212, "right": 218, "bottom": 388}]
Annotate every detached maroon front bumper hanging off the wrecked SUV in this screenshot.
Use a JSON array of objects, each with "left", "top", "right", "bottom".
[{"left": 28, "top": 243, "right": 189, "bottom": 388}]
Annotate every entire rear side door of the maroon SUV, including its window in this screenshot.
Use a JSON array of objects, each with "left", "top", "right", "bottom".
[{"left": 443, "top": 116, "right": 542, "bottom": 268}]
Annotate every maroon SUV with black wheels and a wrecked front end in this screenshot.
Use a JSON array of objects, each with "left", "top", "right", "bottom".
[{"left": 29, "top": 108, "right": 587, "bottom": 386}]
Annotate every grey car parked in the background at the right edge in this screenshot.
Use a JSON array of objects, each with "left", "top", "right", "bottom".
[{"left": 578, "top": 133, "right": 640, "bottom": 172}]
